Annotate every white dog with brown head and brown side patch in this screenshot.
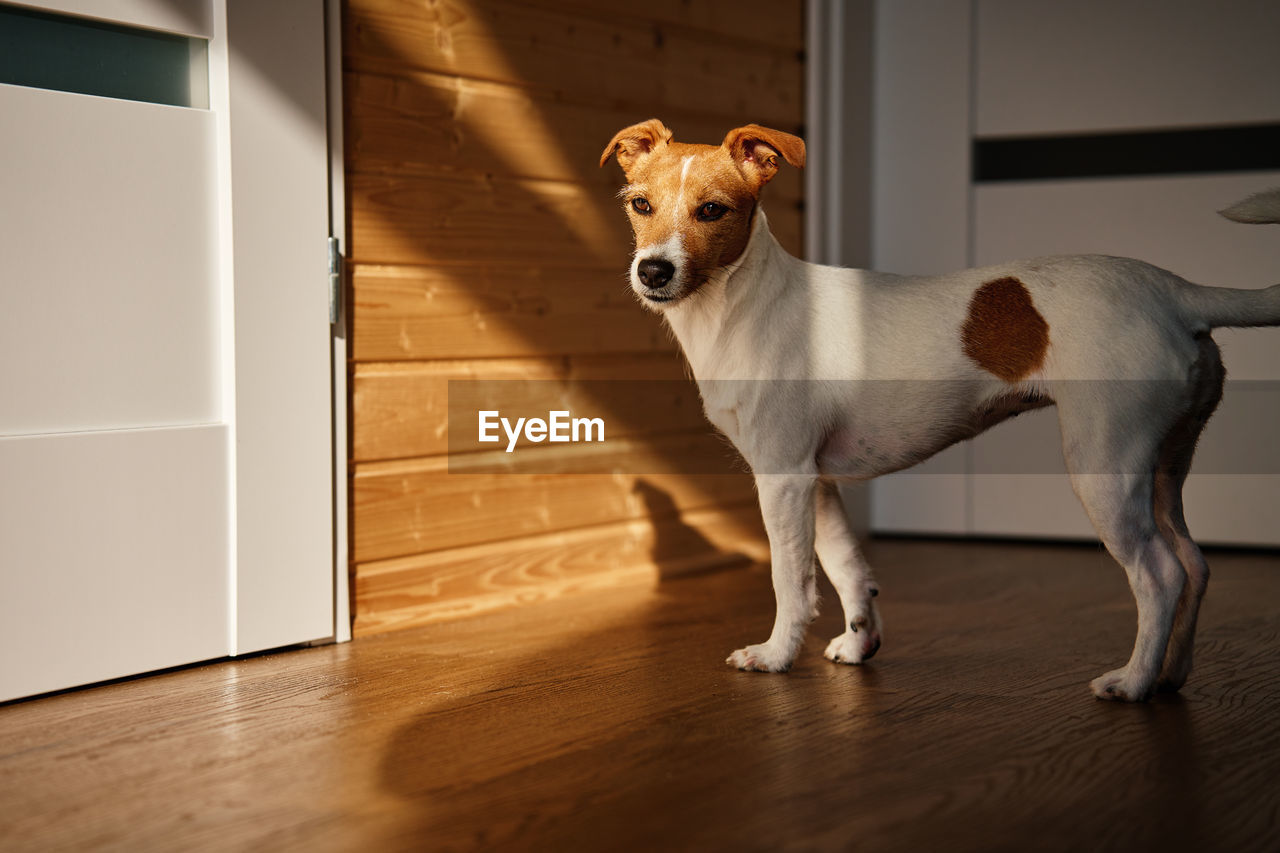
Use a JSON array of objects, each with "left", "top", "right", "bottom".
[{"left": 600, "top": 119, "right": 1280, "bottom": 702}]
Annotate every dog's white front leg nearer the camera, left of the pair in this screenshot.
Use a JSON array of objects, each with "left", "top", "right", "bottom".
[{"left": 726, "top": 474, "right": 818, "bottom": 672}]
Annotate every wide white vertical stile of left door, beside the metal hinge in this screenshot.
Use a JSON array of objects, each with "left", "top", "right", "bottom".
[{"left": 220, "top": 0, "right": 335, "bottom": 654}]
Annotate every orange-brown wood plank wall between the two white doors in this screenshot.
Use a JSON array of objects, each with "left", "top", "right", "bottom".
[{"left": 343, "top": 0, "right": 804, "bottom": 634}]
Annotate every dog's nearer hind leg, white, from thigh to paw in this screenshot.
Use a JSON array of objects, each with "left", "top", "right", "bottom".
[{"left": 1059, "top": 383, "right": 1185, "bottom": 702}]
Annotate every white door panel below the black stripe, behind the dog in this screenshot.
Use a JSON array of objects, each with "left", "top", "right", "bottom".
[{"left": 970, "top": 172, "right": 1280, "bottom": 546}]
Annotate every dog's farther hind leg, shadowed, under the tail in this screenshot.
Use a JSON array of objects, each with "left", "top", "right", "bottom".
[{"left": 1155, "top": 336, "right": 1225, "bottom": 690}]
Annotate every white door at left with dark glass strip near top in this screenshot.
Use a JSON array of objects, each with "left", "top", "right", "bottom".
[{"left": 0, "top": 0, "right": 333, "bottom": 701}]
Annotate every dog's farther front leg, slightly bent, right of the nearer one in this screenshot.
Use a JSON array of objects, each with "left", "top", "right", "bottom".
[{"left": 814, "top": 483, "right": 881, "bottom": 663}]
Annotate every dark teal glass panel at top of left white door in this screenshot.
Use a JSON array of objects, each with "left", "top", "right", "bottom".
[{"left": 0, "top": 5, "right": 209, "bottom": 109}]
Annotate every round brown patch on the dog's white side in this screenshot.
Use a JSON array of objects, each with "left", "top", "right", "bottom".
[{"left": 960, "top": 277, "right": 1048, "bottom": 382}]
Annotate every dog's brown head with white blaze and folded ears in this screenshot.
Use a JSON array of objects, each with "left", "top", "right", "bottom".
[{"left": 600, "top": 119, "right": 804, "bottom": 310}]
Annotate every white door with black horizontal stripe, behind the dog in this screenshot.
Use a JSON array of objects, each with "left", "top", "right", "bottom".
[{"left": 872, "top": 0, "right": 1280, "bottom": 544}]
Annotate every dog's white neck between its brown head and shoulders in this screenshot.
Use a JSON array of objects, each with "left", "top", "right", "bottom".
[{"left": 663, "top": 207, "right": 794, "bottom": 379}]
